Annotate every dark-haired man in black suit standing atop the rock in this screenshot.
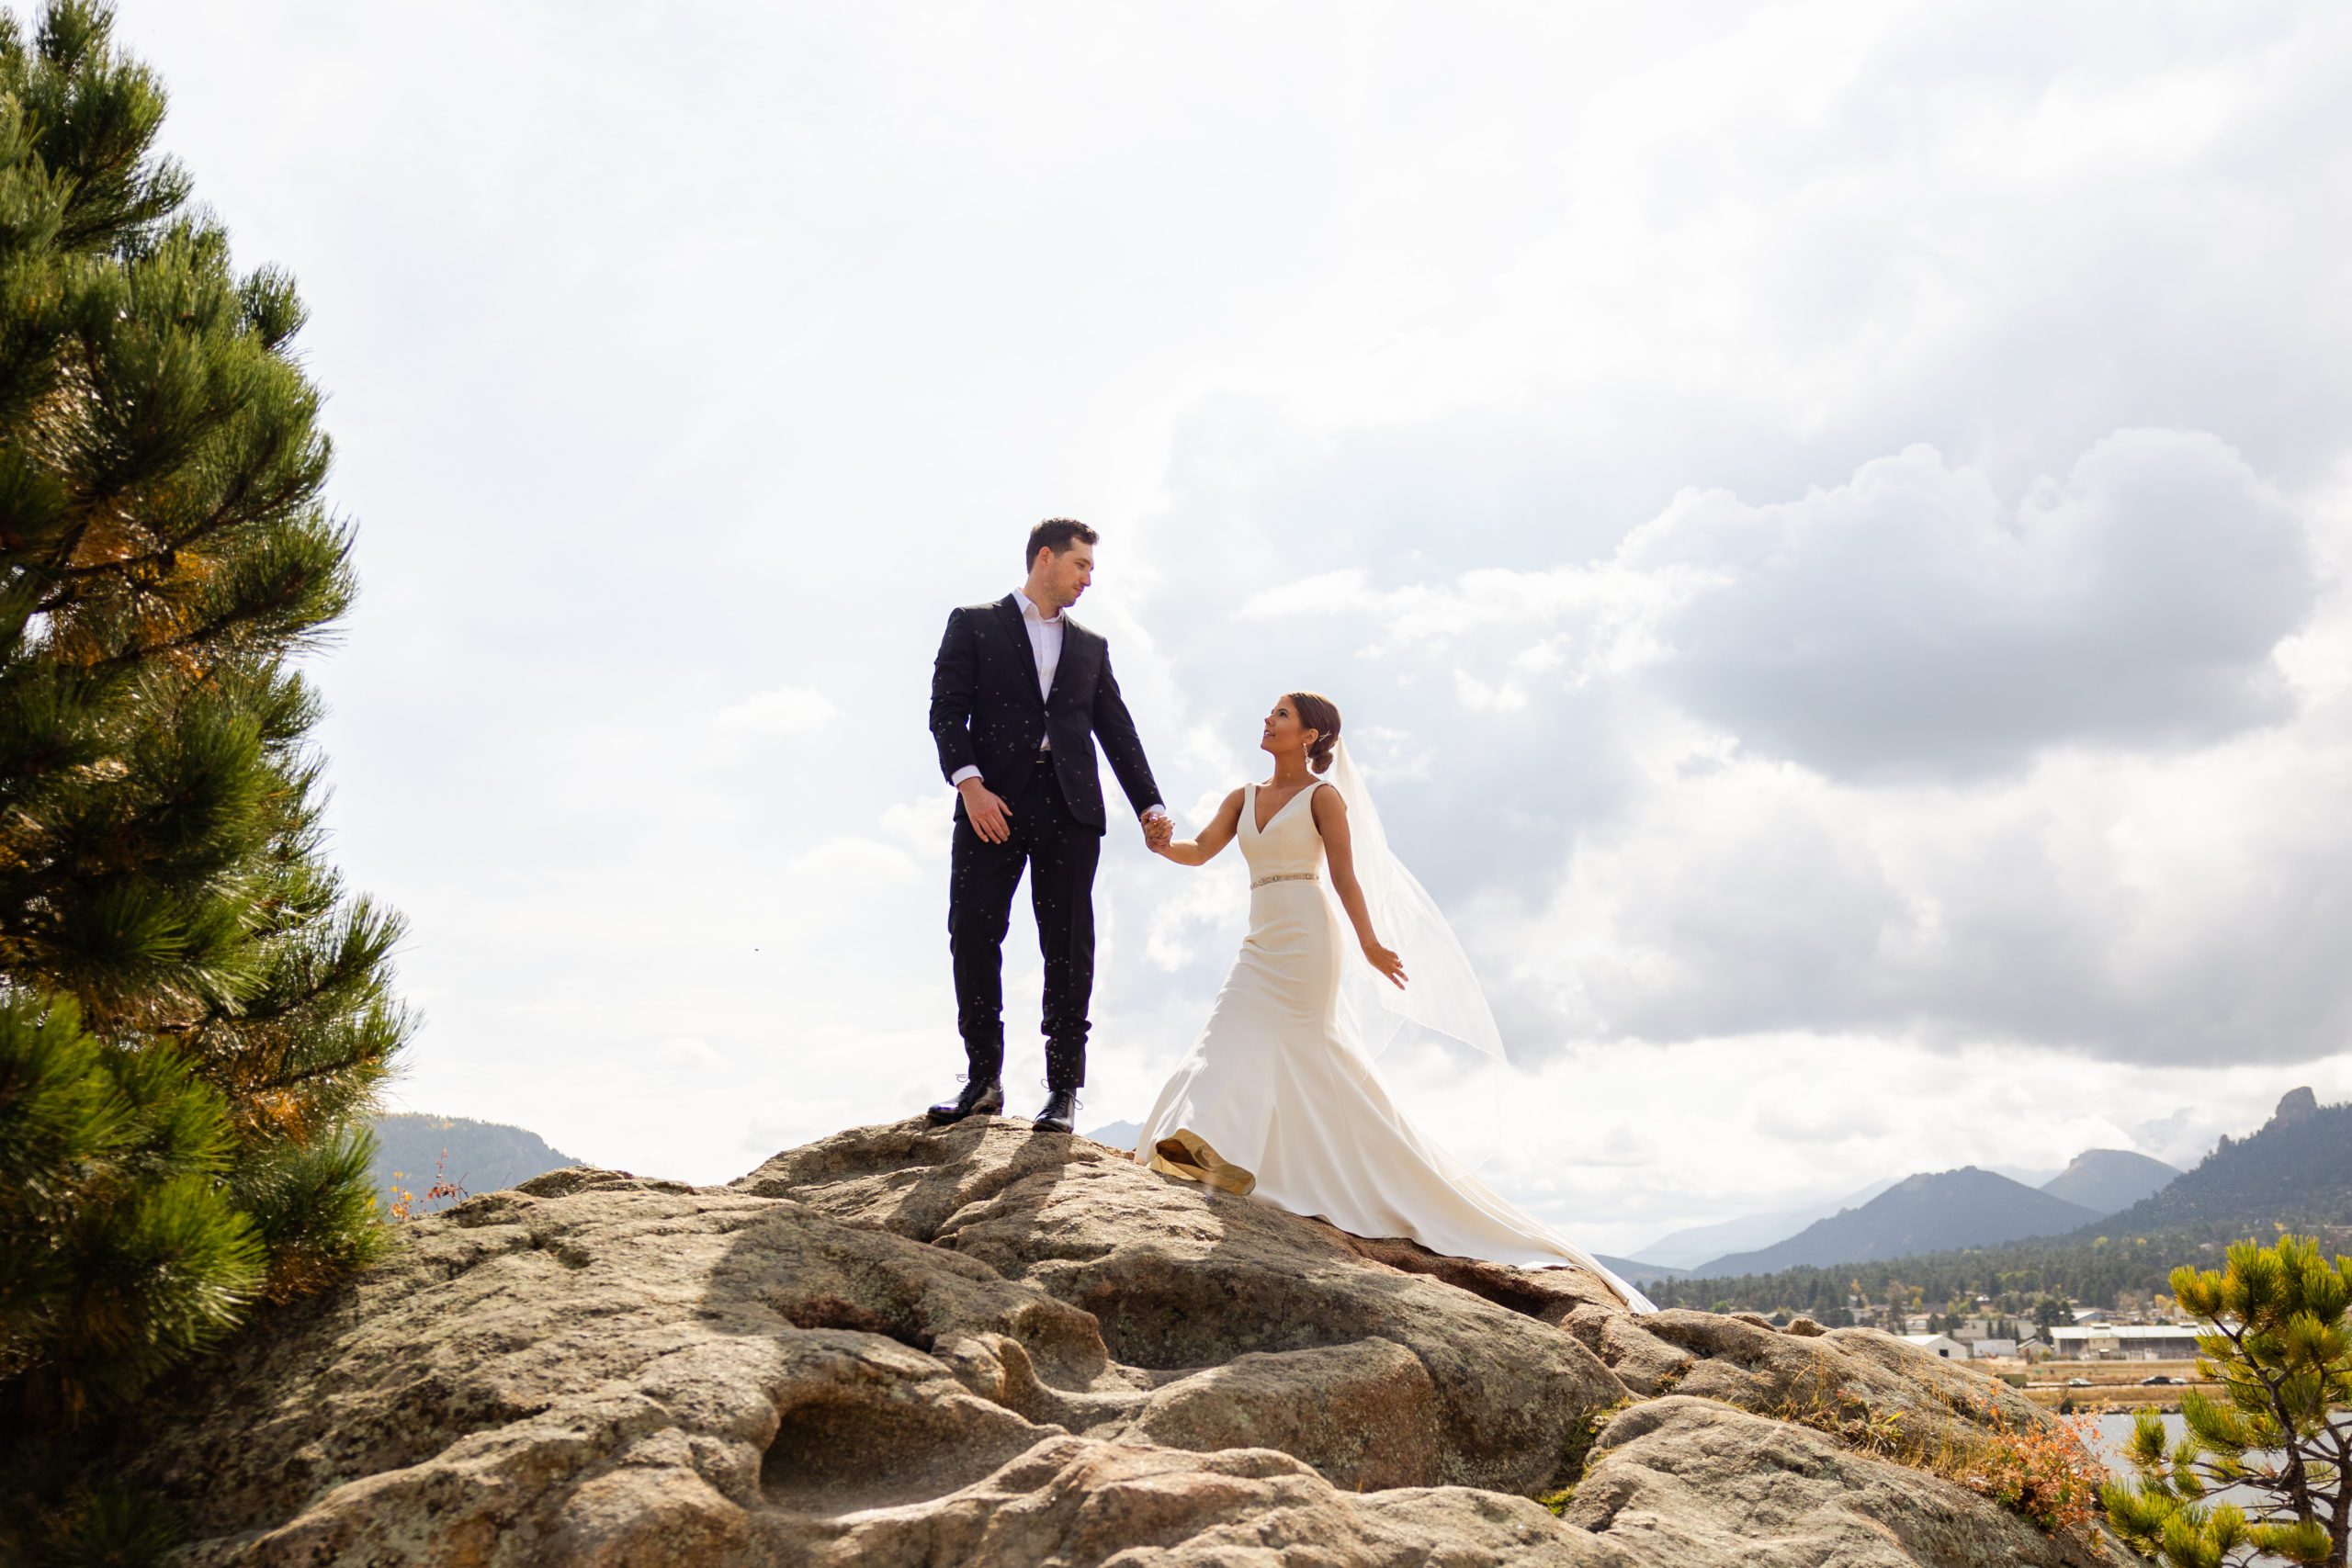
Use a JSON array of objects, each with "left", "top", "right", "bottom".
[{"left": 929, "top": 517, "right": 1171, "bottom": 1134}]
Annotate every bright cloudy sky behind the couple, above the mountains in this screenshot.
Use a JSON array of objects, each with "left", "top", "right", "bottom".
[{"left": 120, "top": 0, "right": 2352, "bottom": 1251}]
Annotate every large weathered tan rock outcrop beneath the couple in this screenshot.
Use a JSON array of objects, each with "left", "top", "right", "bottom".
[{"left": 127, "top": 1122, "right": 2091, "bottom": 1568}]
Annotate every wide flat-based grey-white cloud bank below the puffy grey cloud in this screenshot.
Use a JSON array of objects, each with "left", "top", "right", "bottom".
[{"left": 1520, "top": 691, "right": 2352, "bottom": 1065}]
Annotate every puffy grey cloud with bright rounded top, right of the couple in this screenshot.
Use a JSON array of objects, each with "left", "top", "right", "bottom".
[{"left": 1618, "top": 430, "right": 2317, "bottom": 773}]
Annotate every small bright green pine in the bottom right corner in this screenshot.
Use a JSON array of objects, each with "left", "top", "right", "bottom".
[{"left": 2105, "top": 1236, "right": 2352, "bottom": 1568}]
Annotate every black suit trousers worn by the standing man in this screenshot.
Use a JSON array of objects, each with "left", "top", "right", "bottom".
[{"left": 948, "top": 757, "right": 1103, "bottom": 1089}]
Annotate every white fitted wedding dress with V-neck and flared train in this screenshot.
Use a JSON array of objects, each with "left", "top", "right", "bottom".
[{"left": 1136, "top": 783, "right": 1656, "bottom": 1312}]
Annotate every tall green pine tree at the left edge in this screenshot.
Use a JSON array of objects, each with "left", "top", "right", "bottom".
[{"left": 0, "top": 0, "right": 409, "bottom": 1427}]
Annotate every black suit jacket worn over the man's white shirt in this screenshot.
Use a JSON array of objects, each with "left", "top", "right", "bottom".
[{"left": 932, "top": 594, "right": 1159, "bottom": 832}]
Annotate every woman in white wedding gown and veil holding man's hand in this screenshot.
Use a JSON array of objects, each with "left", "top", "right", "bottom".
[{"left": 1136, "top": 691, "right": 1656, "bottom": 1312}]
